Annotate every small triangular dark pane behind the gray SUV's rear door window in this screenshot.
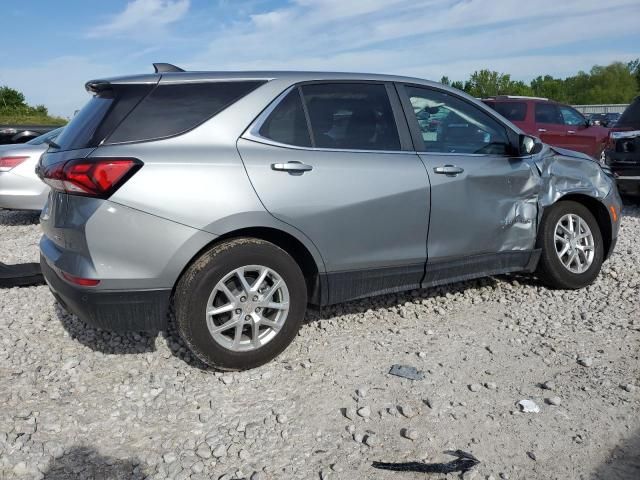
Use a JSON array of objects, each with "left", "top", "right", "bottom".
[{"left": 259, "top": 88, "right": 311, "bottom": 147}]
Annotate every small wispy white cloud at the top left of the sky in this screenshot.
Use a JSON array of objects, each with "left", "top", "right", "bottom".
[{"left": 88, "top": 0, "right": 190, "bottom": 38}]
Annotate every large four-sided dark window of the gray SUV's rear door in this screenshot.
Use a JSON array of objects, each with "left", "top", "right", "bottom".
[{"left": 302, "top": 83, "right": 400, "bottom": 150}]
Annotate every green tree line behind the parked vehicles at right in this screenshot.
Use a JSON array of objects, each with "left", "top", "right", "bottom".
[{"left": 440, "top": 59, "right": 640, "bottom": 105}]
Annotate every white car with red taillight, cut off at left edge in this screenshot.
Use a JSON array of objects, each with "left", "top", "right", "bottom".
[{"left": 0, "top": 127, "right": 63, "bottom": 211}]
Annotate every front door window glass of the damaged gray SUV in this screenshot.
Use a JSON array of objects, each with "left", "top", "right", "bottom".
[{"left": 407, "top": 87, "right": 509, "bottom": 155}]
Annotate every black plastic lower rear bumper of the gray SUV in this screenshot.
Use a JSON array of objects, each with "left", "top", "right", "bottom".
[{"left": 40, "top": 256, "right": 171, "bottom": 332}]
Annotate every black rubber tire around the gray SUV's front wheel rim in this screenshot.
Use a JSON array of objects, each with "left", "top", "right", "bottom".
[{"left": 539, "top": 201, "right": 604, "bottom": 289}]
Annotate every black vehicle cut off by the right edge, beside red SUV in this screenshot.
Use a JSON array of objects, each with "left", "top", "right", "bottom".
[{"left": 603, "top": 97, "right": 640, "bottom": 195}]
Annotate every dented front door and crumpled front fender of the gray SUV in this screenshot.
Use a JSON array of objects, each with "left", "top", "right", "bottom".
[{"left": 420, "top": 146, "right": 617, "bottom": 287}]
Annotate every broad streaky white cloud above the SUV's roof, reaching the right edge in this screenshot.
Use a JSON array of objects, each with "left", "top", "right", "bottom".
[{"left": 186, "top": 0, "right": 640, "bottom": 83}]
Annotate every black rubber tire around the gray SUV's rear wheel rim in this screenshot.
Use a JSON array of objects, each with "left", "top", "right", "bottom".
[{"left": 175, "top": 239, "right": 307, "bottom": 370}]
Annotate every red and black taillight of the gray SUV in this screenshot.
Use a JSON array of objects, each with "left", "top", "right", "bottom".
[{"left": 38, "top": 158, "right": 142, "bottom": 198}]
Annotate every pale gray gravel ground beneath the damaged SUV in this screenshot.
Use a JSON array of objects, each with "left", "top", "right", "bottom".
[{"left": 0, "top": 207, "right": 640, "bottom": 480}]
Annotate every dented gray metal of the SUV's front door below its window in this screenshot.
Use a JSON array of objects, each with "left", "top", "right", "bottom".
[{"left": 420, "top": 153, "right": 540, "bottom": 264}]
